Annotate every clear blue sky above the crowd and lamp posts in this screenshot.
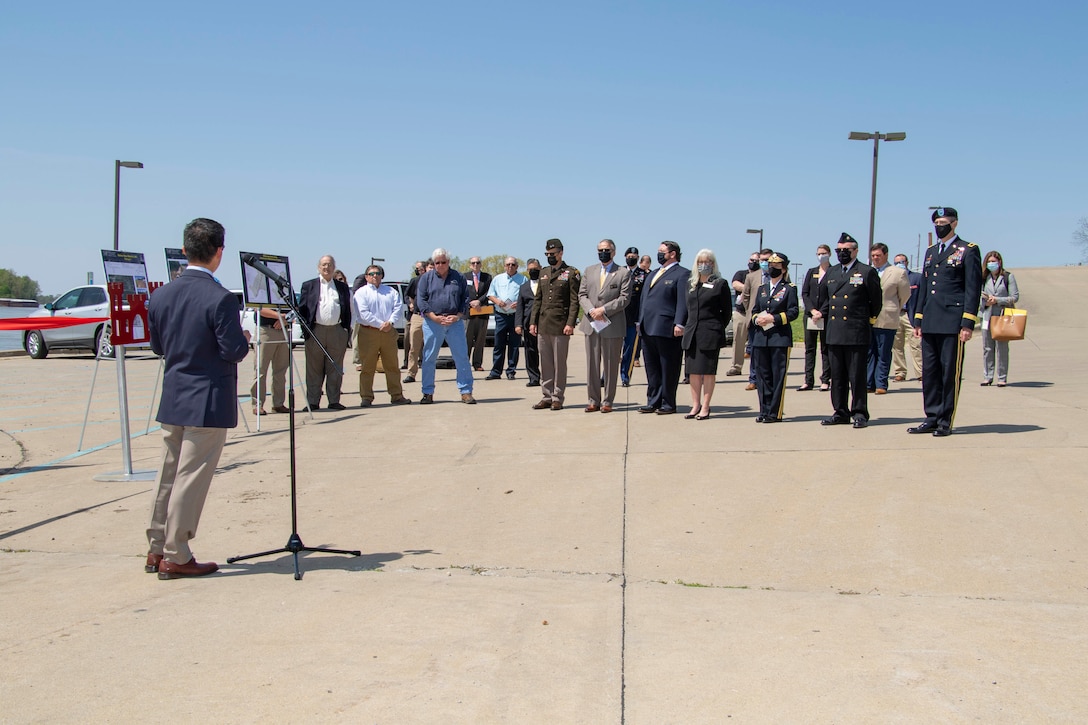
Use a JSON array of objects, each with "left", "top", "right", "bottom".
[{"left": 0, "top": 0, "right": 1088, "bottom": 293}]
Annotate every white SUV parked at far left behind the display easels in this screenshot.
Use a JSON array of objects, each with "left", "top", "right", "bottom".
[{"left": 23, "top": 284, "right": 113, "bottom": 360}]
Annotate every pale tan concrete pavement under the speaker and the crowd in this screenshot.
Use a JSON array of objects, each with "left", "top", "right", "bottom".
[{"left": 0, "top": 268, "right": 1088, "bottom": 723}]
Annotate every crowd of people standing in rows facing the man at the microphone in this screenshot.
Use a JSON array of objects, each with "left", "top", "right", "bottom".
[{"left": 244, "top": 207, "right": 1019, "bottom": 437}]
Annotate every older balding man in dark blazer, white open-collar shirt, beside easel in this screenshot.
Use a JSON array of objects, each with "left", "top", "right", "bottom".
[{"left": 298, "top": 255, "right": 351, "bottom": 410}]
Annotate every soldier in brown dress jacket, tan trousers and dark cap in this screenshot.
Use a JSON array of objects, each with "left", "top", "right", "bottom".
[{"left": 529, "top": 239, "right": 582, "bottom": 410}]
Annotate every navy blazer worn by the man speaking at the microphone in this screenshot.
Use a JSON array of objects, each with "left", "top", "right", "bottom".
[{"left": 148, "top": 269, "right": 249, "bottom": 428}]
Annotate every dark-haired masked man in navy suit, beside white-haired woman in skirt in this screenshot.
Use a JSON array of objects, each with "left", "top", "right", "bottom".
[{"left": 639, "top": 242, "right": 691, "bottom": 416}]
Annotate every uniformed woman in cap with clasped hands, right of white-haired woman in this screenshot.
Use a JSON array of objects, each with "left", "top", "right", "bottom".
[{"left": 749, "top": 253, "right": 800, "bottom": 422}]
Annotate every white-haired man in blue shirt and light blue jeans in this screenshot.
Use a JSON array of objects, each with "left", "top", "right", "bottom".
[{"left": 416, "top": 247, "right": 475, "bottom": 405}]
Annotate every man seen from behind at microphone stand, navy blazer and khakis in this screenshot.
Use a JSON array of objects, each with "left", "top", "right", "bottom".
[{"left": 144, "top": 219, "right": 249, "bottom": 579}]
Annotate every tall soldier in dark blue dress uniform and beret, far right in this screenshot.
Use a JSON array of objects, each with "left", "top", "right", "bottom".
[{"left": 906, "top": 207, "right": 982, "bottom": 437}]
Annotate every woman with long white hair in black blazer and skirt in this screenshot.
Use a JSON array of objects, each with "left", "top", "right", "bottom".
[{"left": 682, "top": 249, "right": 733, "bottom": 420}]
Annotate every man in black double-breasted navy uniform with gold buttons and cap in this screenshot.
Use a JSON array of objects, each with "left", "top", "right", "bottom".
[{"left": 813, "top": 232, "right": 882, "bottom": 428}]
